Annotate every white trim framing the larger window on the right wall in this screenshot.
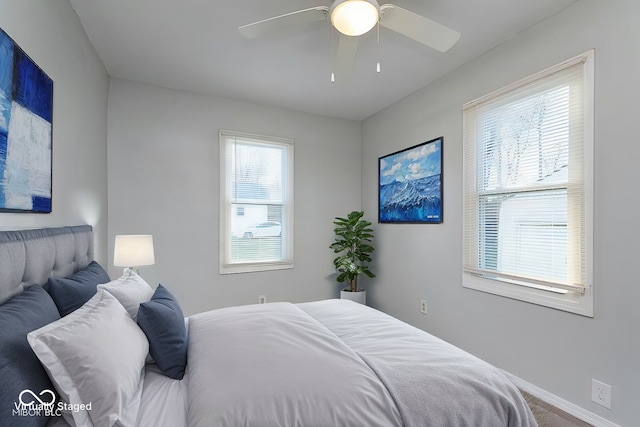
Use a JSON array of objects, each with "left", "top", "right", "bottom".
[{"left": 462, "top": 50, "right": 595, "bottom": 317}]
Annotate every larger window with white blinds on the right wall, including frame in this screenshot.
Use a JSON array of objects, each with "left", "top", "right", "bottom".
[{"left": 463, "top": 51, "right": 594, "bottom": 316}]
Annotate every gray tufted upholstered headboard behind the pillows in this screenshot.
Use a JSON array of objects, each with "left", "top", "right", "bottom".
[{"left": 0, "top": 225, "right": 93, "bottom": 304}]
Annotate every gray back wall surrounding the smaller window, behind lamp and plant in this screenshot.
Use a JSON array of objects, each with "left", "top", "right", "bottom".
[{"left": 108, "top": 80, "right": 362, "bottom": 314}]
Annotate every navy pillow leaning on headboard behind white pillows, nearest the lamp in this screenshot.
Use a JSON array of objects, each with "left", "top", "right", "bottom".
[{"left": 44, "top": 261, "right": 111, "bottom": 316}]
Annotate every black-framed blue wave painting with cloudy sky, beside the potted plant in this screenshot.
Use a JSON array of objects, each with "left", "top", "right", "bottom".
[{"left": 378, "top": 137, "right": 444, "bottom": 224}]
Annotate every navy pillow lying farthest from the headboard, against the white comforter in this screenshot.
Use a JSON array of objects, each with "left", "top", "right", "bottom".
[{"left": 137, "top": 285, "right": 188, "bottom": 380}]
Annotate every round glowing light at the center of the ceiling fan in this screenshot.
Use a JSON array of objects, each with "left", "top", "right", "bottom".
[{"left": 331, "top": 0, "right": 380, "bottom": 36}]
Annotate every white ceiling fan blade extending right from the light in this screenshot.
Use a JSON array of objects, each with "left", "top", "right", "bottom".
[{"left": 380, "top": 4, "right": 460, "bottom": 52}]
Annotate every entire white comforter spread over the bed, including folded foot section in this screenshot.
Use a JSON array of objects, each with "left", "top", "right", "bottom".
[{"left": 187, "top": 300, "right": 536, "bottom": 427}]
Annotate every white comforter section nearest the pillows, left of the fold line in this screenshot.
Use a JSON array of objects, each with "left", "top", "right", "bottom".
[{"left": 188, "top": 303, "right": 402, "bottom": 427}]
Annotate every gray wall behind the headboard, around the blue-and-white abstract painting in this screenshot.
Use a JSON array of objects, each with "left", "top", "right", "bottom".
[{"left": 0, "top": 0, "right": 109, "bottom": 263}]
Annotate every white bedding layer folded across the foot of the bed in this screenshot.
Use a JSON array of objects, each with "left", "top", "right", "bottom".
[{"left": 298, "top": 300, "right": 537, "bottom": 427}]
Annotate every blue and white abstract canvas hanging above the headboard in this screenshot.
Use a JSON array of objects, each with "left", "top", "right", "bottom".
[{"left": 0, "top": 29, "right": 53, "bottom": 213}]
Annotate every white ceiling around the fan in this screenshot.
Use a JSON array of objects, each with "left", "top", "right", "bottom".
[{"left": 70, "top": 0, "right": 577, "bottom": 120}]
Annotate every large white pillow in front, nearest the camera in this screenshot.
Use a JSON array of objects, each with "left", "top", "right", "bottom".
[{"left": 27, "top": 290, "right": 149, "bottom": 427}]
